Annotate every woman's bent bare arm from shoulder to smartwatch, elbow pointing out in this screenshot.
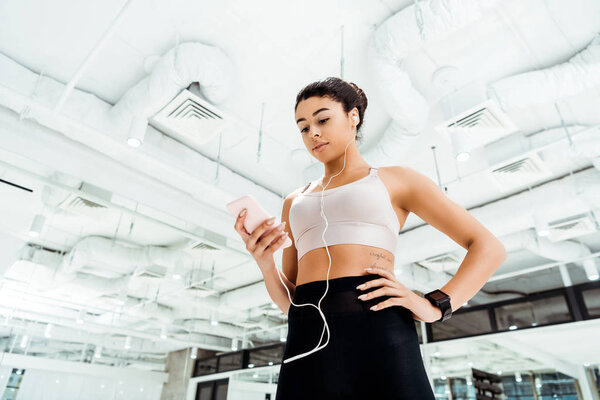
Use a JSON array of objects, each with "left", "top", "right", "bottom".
[{"left": 393, "top": 167, "right": 506, "bottom": 317}]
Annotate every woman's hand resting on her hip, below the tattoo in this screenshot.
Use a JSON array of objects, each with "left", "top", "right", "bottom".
[{"left": 360, "top": 267, "right": 442, "bottom": 322}]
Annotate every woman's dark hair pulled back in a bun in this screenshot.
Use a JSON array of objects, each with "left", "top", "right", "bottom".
[{"left": 294, "top": 76, "right": 368, "bottom": 142}]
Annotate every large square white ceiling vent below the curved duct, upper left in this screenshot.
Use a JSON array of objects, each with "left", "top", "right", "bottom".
[{"left": 150, "top": 82, "right": 226, "bottom": 145}]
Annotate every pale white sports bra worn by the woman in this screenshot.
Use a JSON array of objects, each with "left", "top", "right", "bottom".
[{"left": 289, "top": 167, "right": 400, "bottom": 261}]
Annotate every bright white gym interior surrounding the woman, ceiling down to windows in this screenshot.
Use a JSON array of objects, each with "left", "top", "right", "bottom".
[{"left": 0, "top": 0, "right": 600, "bottom": 400}]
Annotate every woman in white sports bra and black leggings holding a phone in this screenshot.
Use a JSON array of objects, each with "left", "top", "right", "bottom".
[{"left": 235, "top": 77, "right": 506, "bottom": 400}]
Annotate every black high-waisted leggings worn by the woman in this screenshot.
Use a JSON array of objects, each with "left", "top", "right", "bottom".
[{"left": 275, "top": 274, "right": 435, "bottom": 400}]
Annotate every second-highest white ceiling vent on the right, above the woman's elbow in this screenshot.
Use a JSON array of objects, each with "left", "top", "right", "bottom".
[{"left": 491, "top": 153, "right": 552, "bottom": 192}]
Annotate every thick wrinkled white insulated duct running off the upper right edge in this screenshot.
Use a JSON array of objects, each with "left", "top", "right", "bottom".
[{"left": 488, "top": 34, "right": 600, "bottom": 126}]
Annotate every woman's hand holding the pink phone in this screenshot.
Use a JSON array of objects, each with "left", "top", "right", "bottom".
[{"left": 235, "top": 209, "right": 288, "bottom": 269}]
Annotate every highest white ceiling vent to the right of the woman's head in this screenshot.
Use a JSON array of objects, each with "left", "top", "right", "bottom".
[{"left": 436, "top": 100, "right": 517, "bottom": 137}]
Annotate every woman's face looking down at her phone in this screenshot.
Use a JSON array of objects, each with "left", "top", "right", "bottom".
[{"left": 296, "top": 96, "right": 359, "bottom": 160}]
